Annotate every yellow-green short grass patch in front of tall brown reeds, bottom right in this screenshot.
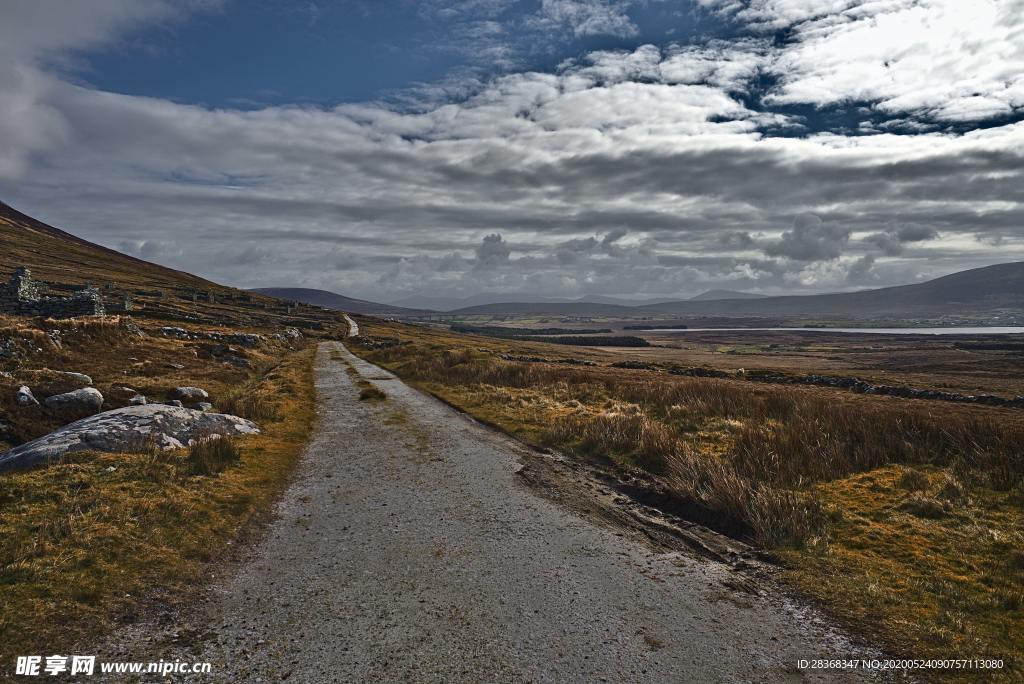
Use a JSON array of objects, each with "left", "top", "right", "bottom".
[{"left": 778, "top": 466, "right": 1024, "bottom": 679}]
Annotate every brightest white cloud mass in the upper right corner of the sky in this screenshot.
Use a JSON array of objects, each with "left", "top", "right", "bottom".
[{"left": 701, "top": 0, "right": 1024, "bottom": 122}]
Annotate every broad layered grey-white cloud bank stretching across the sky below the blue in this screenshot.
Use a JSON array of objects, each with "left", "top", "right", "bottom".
[{"left": 0, "top": 0, "right": 1024, "bottom": 298}]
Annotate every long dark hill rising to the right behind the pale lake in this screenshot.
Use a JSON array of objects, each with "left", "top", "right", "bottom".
[{"left": 454, "top": 262, "right": 1024, "bottom": 319}]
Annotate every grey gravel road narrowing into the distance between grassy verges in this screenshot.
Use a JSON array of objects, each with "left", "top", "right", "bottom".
[{"left": 114, "top": 343, "right": 880, "bottom": 683}]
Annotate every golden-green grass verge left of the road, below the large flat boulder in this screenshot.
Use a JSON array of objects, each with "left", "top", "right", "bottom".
[{"left": 0, "top": 346, "right": 315, "bottom": 659}]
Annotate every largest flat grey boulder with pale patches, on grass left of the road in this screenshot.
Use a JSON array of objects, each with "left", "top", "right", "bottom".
[{"left": 0, "top": 403, "right": 259, "bottom": 472}]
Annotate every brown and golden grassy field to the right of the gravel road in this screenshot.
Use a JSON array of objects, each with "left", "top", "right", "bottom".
[{"left": 354, "top": 320, "right": 1024, "bottom": 677}]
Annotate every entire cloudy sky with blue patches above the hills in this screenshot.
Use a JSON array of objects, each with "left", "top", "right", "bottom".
[{"left": 0, "top": 0, "right": 1024, "bottom": 301}]
